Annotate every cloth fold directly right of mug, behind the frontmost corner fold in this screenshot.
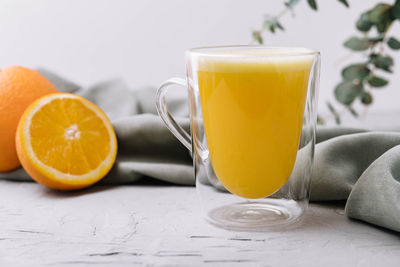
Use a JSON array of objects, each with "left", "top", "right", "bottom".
[{"left": 311, "top": 132, "right": 400, "bottom": 201}]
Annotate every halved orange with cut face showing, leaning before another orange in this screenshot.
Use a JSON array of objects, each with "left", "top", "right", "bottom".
[{"left": 16, "top": 93, "right": 117, "bottom": 190}]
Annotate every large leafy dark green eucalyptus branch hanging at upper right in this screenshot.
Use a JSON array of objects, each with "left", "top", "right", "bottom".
[{"left": 334, "top": 0, "right": 400, "bottom": 122}]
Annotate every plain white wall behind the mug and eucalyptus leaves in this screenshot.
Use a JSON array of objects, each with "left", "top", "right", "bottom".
[{"left": 0, "top": 0, "right": 400, "bottom": 117}]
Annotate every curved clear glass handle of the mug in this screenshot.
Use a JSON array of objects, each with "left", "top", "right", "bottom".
[{"left": 156, "top": 78, "right": 192, "bottom": 153}]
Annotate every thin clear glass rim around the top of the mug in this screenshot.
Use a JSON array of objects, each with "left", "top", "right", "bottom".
[{"left": 186, "top": 45, "right": 320, "bottom": 58}]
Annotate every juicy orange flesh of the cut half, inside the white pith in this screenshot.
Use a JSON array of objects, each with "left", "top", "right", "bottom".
[{"left": 29, "top": 99, "right": 111, "bottom": 175}]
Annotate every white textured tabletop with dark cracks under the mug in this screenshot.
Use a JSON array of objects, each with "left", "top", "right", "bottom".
[{"left": 0, "top": 181, "right": 400, "bottom": 266}]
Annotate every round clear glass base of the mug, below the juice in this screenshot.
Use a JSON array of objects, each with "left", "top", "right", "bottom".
[{"left": 207, "top": 199, "right": 304, "bottom": 232}]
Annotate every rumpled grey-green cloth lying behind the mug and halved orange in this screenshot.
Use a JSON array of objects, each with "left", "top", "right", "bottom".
[{"left": 0, "top": 70, "right": 400, "bottom": 232}]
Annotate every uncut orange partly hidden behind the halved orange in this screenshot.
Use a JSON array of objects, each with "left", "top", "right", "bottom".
[{"left": 0, "top": 66, "right": 58, "bottom": 172}]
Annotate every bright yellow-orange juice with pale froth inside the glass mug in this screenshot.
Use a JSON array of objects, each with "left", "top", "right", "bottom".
[{"left": 198, "top": 51, "right": 312, "bottom": 198}]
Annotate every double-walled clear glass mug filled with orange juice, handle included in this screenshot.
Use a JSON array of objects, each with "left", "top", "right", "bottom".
[{"left": 156, "top": 46, "right": 320, "bottom": 231}]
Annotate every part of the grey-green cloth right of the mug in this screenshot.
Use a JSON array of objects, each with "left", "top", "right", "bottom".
[{"left": 311, "top": 128, "right": 400, "bottom": 232}]
